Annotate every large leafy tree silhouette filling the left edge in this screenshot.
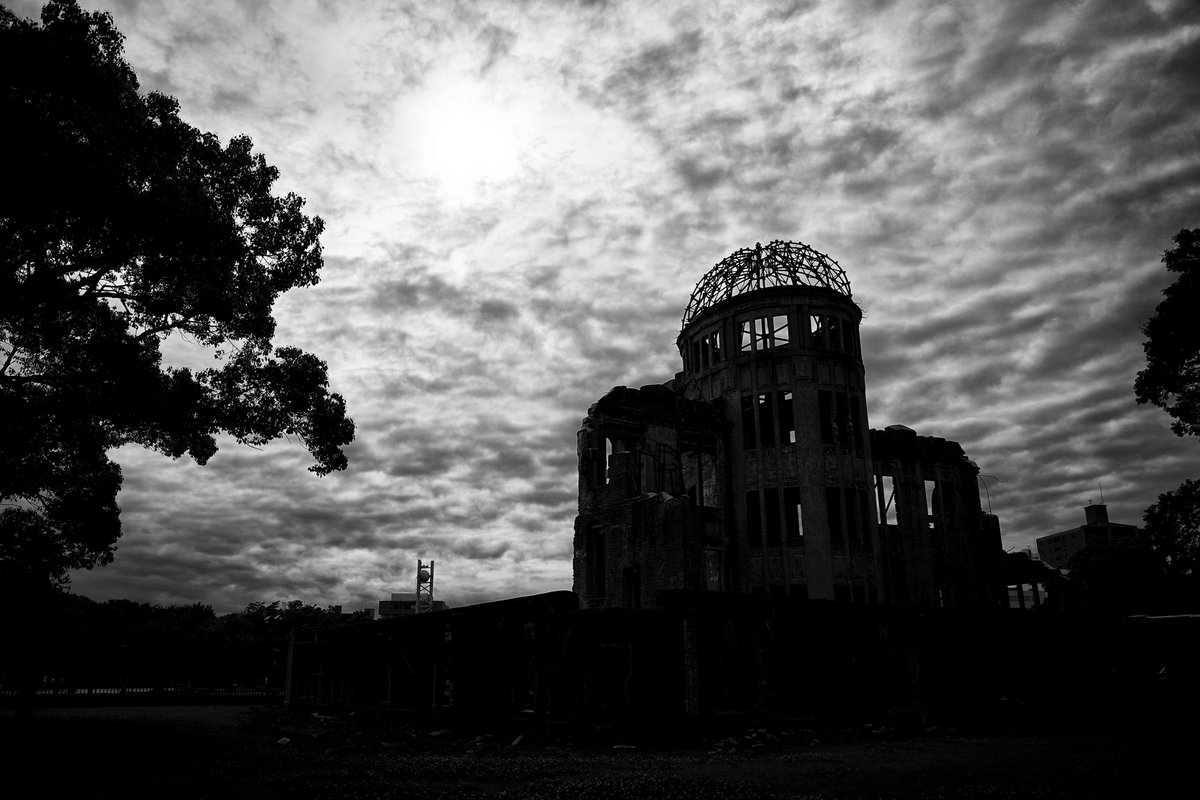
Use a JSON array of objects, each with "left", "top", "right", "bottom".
[{"left": 0, "top": 0, "right": 354, "bottom": 582}]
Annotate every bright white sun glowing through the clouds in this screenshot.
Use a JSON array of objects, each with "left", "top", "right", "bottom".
[{"left": 401, "top": 71, "right": 520, "bottom": 204}]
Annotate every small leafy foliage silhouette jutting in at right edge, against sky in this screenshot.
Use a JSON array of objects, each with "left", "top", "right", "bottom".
[{"left": 1134, "top": 228, "right": 1200, "bottom": 437}]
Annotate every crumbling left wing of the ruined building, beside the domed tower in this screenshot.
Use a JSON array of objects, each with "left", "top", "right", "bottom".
[{"left": 574, "top": 386, "right": 726, "bottom": 608}]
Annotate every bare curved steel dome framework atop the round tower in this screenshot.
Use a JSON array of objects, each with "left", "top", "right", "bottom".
[{"left": 683, "top": 240, "right": 851, "bottom": 329}]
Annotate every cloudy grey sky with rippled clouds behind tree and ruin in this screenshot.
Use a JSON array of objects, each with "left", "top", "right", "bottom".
[{"left": 10, "top": 0, "right": 1200, "bottom": 612}]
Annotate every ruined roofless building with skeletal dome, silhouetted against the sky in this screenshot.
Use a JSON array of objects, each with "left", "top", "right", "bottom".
[{"left": 575, "top": 241, "right": 1003, "bottom": 607}]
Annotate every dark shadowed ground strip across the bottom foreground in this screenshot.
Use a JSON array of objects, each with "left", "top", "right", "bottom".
[{"left": 0, "top": 706, "right": 1200, "bottom": 800}]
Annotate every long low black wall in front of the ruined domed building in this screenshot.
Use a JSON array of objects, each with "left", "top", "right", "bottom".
[{"left": 287, "top": 591, "right": 1200, "bottom": 724}]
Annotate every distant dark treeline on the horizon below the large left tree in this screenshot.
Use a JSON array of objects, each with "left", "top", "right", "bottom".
[{"left": 0, "top": 593, "right": 370, "bottom": 690}]
